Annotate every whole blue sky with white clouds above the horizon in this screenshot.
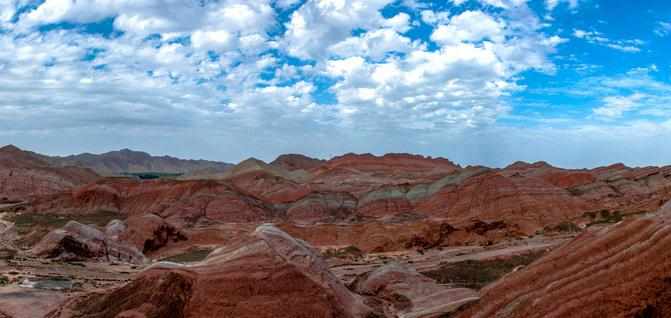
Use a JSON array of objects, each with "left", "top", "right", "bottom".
[{"left": 0, "top": 0, "right": 671, "bottom": 167}]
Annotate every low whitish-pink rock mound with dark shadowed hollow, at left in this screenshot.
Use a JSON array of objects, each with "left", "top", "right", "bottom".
[{"left": 32, "top": 221, "right": 146, "bottom": 264}]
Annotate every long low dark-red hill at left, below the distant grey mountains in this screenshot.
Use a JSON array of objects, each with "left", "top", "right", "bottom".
[{"left": 26, "top": 179, "right": 273, "bottom": 224}]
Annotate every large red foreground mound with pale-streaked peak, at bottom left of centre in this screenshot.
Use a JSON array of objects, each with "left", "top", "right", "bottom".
[{"left": 48, "top": 225, "right": 379, "bottom": 318}]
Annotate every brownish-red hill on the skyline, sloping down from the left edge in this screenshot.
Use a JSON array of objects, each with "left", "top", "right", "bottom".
[{"left": 0, "top": 146, "right": 98, "bottom": 201}]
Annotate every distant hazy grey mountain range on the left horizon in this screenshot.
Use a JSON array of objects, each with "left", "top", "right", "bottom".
[{"left": 44, "top": 149, "right": 233, "bottom": 176}]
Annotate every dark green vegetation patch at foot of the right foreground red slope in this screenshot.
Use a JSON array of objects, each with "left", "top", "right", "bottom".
[{"left": 422, "top": 251, "right": 545, "bottom": 290}]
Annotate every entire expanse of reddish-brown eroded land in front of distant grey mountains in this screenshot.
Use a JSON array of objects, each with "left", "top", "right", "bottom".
[{"left": 0, "top": 147, "right": 671, "bottom": 318}]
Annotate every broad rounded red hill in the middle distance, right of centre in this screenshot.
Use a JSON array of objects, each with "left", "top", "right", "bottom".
[{"left": 417, "top": 171, "right": 590, "bottom": 234}]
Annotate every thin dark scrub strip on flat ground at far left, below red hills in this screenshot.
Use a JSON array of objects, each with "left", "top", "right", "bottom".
[{"left": 7, "top": 210, "right": 121, "bottom": 235}]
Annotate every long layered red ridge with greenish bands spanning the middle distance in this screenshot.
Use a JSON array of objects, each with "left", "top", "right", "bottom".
[{"left": 5, "top": 145, "right": 671, "bottom": 255}]
